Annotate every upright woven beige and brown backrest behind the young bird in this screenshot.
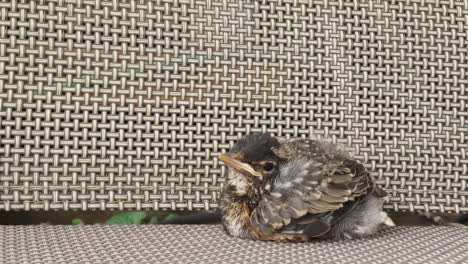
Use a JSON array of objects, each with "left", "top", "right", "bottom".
[{"left": 0, "top": 0, "right": 468, "bottom": 212}]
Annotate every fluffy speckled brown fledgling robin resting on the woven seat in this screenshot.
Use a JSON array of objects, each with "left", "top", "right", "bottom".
[{"left": 219, "top": 134, "right": 387, "bottom": 242}]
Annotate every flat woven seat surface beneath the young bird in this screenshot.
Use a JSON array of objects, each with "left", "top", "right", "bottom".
[{"left": 0, "top": 225, "right": 468, "bottom": 264}]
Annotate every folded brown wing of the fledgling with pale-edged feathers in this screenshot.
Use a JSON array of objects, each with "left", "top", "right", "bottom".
[{"left": 251, "top": 140, "right": 382, "bottom": 235}]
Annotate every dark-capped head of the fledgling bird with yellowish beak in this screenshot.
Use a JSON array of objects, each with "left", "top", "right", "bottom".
[{"left": 219, "top": 133, "right": 281, "bottom": 187}]
